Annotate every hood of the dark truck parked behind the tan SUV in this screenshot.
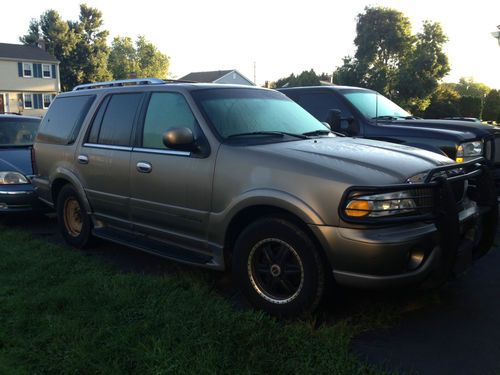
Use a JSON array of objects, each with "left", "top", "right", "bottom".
[{"left": 378, "top": 119, "right": 500, "bottom": 138}]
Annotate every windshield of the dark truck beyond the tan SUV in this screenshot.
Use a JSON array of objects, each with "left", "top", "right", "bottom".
[{"left": 344, "top": 91, "right": 411, "bottom": 119}]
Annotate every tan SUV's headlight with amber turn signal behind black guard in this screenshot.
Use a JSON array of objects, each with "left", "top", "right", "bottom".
[{"left": 344, "top": 191, "right": 416, "bottom": 217}]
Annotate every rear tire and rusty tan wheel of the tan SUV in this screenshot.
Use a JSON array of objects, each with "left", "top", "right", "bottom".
[{"left": 57, "top": 185, "right": 92, "bottom": 249}]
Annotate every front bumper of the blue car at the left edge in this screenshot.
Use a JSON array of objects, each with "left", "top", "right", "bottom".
[{"left": 0, "top": 184, "right": 47, "bottom": 213}]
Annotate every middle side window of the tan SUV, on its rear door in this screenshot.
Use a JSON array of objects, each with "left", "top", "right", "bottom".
[{"left": 98, "top": 93, "right": 143, "bottom": 146}]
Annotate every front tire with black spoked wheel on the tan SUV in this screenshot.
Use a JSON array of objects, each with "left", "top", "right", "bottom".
[{"left": 232, "top": 218, "right": 325, "bottom": 318}]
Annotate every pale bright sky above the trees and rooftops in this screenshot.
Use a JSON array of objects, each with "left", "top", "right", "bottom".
[{"left": 0, "top": 0, "right": 500, "bottom": 89}]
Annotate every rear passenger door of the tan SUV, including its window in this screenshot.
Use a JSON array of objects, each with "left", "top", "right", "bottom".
[{"left": 77, "top": 92, "right": 144, "bottom": 229}]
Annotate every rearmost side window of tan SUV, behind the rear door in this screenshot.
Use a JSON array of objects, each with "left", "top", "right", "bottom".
[{"left": 36, "top": 95, "right": 95, "bottom": 144}]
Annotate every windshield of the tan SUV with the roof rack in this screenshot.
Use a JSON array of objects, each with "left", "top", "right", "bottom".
[{"left": 192, "top": 88, "right": 328, "bottom": 140}]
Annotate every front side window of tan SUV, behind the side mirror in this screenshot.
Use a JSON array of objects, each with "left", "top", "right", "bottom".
[{"left": 142, "top": 92, "right": 197, "bottom": 148}]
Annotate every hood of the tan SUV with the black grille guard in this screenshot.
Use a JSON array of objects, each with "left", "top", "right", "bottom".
[{"left": 253, "top": 137, "right": 454, "bottom": 185}]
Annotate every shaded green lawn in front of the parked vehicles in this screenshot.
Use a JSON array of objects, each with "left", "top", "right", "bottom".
[{"left": 0, "top": 227, "right": 390, "bottom": 374}]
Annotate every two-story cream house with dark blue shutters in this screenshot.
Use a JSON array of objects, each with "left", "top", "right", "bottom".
[{"left": 0, "top": 42, "right": 61, "bottom": 116}]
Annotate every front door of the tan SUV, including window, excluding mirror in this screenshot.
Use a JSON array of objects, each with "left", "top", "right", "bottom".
[{"left": 130, "top": 92, "right": 215, "bottom": 250}]
